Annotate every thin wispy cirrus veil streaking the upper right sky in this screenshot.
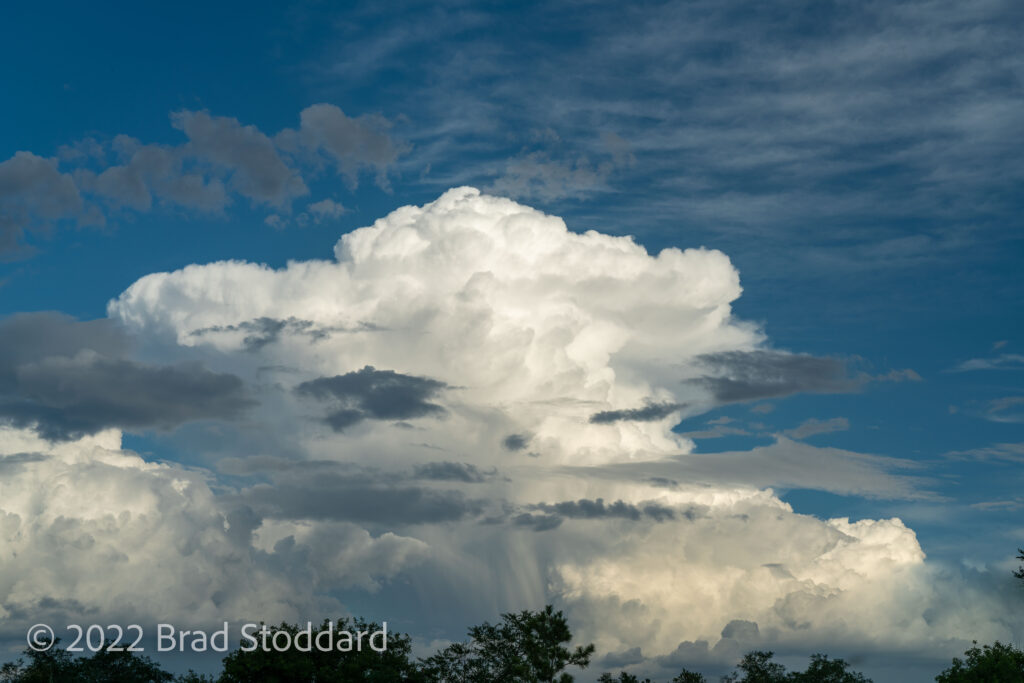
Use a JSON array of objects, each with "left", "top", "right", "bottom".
[{"left": 312, "top": 0, "right": 1024, "bottom": 278}]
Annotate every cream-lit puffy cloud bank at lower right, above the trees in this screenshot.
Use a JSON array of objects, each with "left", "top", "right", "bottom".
[{"left": 555, "top": 501, "right": 1005, "bottom": 656}]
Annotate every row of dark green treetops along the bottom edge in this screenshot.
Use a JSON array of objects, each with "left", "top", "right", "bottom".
[{"left": 0, "top": 610, "right": 1024, "bottom": 683}]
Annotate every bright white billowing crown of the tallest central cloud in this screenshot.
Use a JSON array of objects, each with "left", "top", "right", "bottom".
[{"left": 111, "top": 188, "right": 759, "bottom": 462}]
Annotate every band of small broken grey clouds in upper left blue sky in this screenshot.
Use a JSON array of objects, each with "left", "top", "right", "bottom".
[{"left": 0, "top": 103, "right": 404, "bottom": 255}]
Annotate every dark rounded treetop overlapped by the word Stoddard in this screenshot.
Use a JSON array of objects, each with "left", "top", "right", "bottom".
[{"left": 218, "top": 620, "right": 424, "bottom": 683}]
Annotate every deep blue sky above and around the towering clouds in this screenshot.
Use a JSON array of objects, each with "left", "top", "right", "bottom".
[{"left": 0, "top": 0, "right": 1024, "bottom": 680}]
